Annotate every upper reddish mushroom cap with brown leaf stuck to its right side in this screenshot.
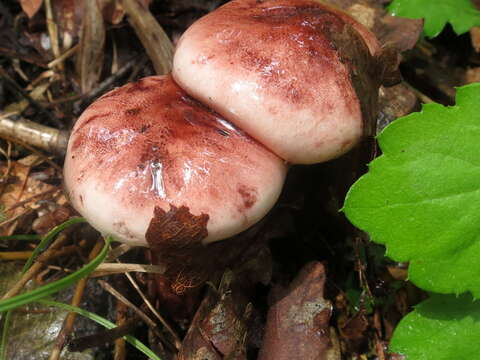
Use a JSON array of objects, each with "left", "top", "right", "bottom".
[{"left": 173, "top": 0, "right": 380, "bottom": 164}]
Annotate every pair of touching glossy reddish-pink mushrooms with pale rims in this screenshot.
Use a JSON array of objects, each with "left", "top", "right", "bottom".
[{"left": 65, "top": 0, "right": 390, "bottom": 260}]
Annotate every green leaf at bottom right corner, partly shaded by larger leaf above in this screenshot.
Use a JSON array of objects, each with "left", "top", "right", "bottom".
[{"left": 390, "top": 295, "right": 480, "bottom": 360}]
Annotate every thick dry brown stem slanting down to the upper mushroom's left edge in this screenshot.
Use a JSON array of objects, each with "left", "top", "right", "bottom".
[{"left": 121, "top": 0, "right": 173, "bottom": 75}]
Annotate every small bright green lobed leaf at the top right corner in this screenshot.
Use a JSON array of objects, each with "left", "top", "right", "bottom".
[{"left": 388, "top": 0, "right": 480, "bottom": 37}]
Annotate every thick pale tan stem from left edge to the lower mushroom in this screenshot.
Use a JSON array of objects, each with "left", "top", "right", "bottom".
[{"left": 0, "top": 113, "right": 69, "bottom": 155}]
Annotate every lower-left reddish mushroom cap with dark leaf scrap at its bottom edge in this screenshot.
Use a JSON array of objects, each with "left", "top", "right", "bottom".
[{"left": 64, "top": 76, "right": 286, "bottom": 246}]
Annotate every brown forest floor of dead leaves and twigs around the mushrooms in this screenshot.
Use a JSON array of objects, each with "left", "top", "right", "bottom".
[{"left": 0, "top": 0, "right": 480, "bottom": 360}]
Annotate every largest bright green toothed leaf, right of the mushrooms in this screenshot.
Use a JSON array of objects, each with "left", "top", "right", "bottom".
[{"left": 343, "top": 83, "right": 480, "bottom": 297}]
